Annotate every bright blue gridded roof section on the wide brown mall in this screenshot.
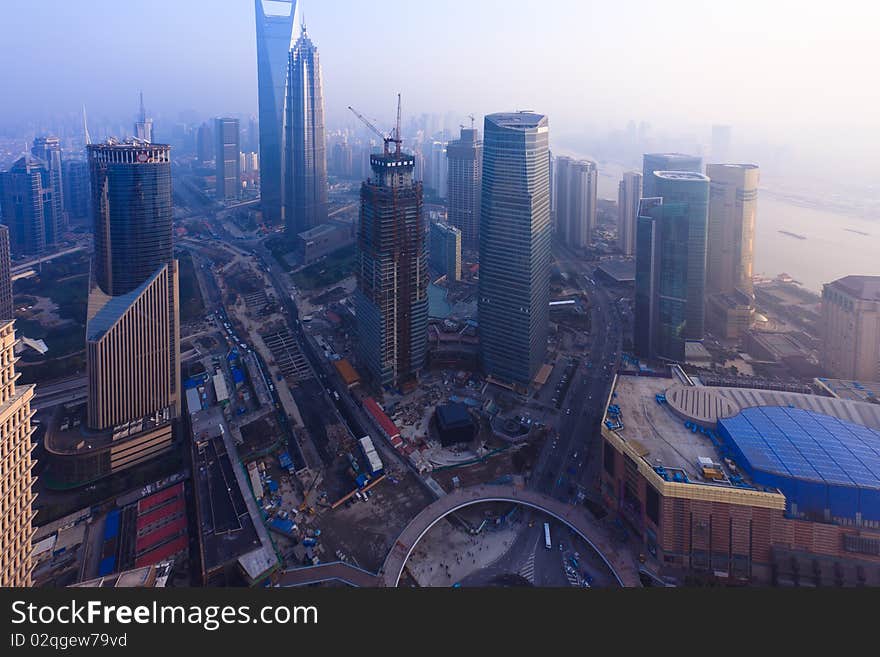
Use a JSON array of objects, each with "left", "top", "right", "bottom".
[{"left": 718, "top": 406, "right": 880, "bottom": 489}]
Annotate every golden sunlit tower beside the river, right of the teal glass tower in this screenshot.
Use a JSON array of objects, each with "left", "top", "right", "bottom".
[{"left": 706, "top": 164, "right": 760, "bottom": 339}]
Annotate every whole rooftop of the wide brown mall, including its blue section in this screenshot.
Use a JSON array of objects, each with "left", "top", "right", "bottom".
[{"left": 606, "top": 376, "right": 880, "bottom": 486}]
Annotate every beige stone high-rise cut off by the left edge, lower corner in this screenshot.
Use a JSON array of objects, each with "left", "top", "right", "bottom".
[{"left": 0, "top": 320, "right": 36, "bottom": 587}]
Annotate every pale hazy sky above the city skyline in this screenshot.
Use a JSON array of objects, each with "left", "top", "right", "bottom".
[{"left": 0, "top": 0, "right": 880, "bottom": 177}]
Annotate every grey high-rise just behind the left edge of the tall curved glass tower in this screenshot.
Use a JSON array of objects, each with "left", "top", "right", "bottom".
[{"left": 446, "top": 128, "right": 483, "bottom": 250}]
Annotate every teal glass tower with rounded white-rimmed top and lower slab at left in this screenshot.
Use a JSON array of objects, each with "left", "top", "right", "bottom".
[{"left": 635, "top": 170, "right": 709, "bottom": 362}]
